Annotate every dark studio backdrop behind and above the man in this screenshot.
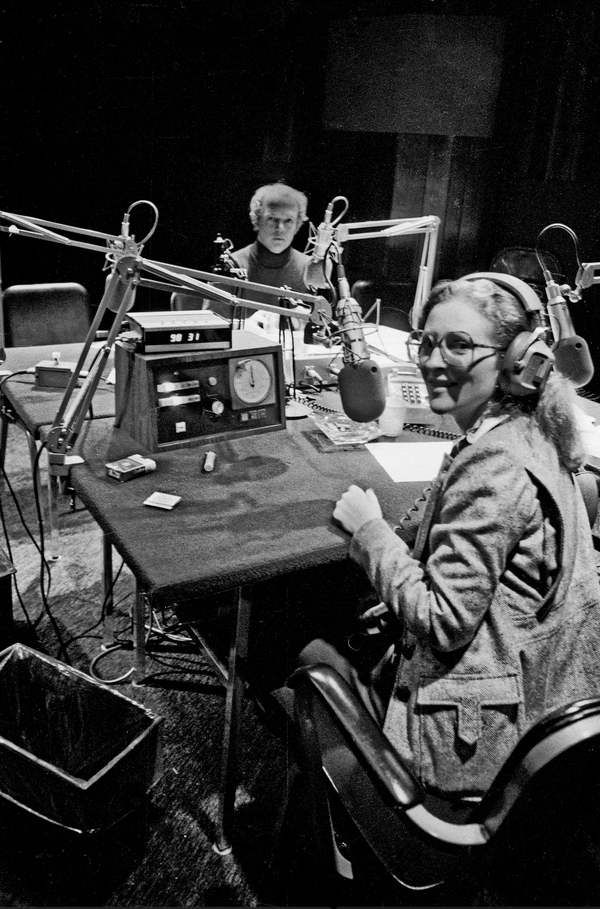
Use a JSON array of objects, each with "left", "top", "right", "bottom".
[{"left": 0, "top": 0, "right": 600, "bottom": 393}]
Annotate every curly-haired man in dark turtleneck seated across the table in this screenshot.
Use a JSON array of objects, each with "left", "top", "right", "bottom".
[{"left": 232, "top": 183, "right": 310, "bottom": 316}]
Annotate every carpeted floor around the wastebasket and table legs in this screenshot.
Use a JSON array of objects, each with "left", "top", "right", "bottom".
[{"left": 0, "top": 427, "right": 321, "bottom": 906}]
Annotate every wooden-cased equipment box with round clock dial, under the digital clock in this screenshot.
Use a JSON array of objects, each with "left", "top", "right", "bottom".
[{"left": 115, "top": 331, "right": 285, "bottom": 452}]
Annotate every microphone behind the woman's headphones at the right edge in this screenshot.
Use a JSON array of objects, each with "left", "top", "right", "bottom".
[{"left": 544, "top": 269, "right": 594, "bottom": 388}]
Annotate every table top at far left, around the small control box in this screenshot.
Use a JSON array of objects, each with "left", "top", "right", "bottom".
[{"left": 2, "top": 344, "right": 115, "bottom": 439}]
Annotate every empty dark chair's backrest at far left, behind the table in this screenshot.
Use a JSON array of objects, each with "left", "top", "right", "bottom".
[{"left": 2, "top": 282, "right": 92, "bottom": 347}]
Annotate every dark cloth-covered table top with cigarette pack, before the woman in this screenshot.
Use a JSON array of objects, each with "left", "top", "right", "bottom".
[{"left": 71, "top": 419, "right": 438, "bottom": 605}]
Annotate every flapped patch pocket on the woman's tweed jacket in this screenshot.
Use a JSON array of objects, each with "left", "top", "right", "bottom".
[{"left": 416, "top": 673, "right": 523, "bottom": 795}]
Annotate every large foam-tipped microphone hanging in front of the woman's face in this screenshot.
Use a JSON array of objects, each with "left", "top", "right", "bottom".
[{"left": 336, "top": 263, "right": 385, "bottom": 423}]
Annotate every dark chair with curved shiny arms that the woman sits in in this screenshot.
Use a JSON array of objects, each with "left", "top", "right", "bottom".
[{"left": 288, "top": 664, "right": 600, "bottom": 906}]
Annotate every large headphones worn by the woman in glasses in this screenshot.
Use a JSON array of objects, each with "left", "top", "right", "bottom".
[{"left": 462, "top": 271, "right": 554, "bottom": 397}]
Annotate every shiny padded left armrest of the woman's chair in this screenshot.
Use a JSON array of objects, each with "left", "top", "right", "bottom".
[{"left": 287, "top": 663, "right": 424, "bottom": 810}]
